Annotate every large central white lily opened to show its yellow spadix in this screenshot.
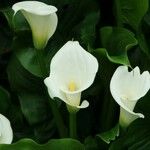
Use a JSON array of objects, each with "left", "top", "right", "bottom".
[{"left": 44, "top": 41, "right": 98, "bottom": 111}]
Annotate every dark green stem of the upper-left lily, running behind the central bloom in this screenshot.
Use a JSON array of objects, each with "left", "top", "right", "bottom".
[{"left": 36, "top": 49, "right": 67, "bottom": 138}]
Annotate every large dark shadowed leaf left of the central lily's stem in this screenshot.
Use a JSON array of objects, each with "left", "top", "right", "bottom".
[{"left": 7, "top": 56, "right": 51, "bottom": 124}]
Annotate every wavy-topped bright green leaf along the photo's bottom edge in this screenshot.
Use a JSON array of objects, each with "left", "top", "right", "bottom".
[{"left": 0, "top": 138, "right": 84, "bottom": 150}]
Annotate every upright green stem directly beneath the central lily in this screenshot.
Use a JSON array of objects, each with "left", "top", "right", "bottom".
[{"left": 69, "top": 113, "right": 77, "bottom": 139}]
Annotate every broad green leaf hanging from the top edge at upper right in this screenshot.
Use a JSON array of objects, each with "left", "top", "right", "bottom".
[{"left": 115, "top": 0, "right": 149, "bottom": 30}]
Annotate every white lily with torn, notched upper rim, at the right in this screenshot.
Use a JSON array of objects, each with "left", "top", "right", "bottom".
[{"left": 110, "top": 66, "right": 150, "bottom": 128}]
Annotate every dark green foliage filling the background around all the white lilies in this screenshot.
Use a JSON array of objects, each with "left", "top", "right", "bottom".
[{"left": 0, "top": 0, "right": 150, "bottom": 150}]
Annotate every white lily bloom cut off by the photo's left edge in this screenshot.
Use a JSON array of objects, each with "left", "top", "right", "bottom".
[{"left": 0, "top": 114, "right": 13, "bottom": 144}]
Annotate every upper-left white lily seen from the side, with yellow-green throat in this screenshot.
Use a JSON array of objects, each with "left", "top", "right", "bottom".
[{"left": 12, "top": 1, "right": 58, "bottom": 49}]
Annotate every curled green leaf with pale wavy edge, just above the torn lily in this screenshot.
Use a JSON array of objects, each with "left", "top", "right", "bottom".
[{"left": 97, "top": 27, "right": 137, "bottom": 66}]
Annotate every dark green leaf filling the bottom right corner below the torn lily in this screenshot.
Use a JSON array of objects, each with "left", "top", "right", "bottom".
[{"left": 110, "top": 119, "right": 150, "bottom": 150}]
